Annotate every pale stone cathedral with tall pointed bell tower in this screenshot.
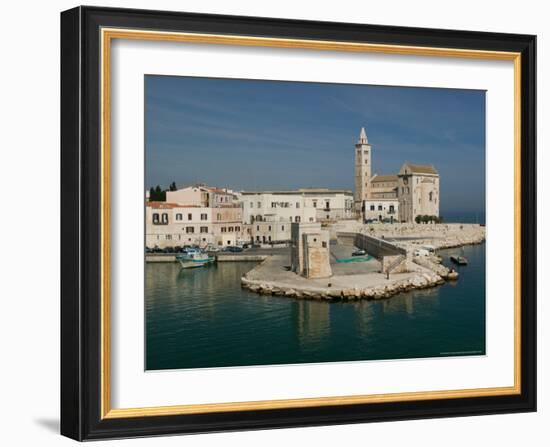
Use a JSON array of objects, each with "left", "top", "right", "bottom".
[{"left": 354, "top": 127, "right": 439, "bottom": 222}]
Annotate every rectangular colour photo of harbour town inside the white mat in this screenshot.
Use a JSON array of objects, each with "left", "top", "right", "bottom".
[{"left": 144, "top": 76, "right": 486, "bottom": 370}]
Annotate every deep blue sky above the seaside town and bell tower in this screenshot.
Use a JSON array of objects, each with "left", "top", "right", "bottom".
[{"left": 145, "top": 75, "right": 485, "bottom": 215}]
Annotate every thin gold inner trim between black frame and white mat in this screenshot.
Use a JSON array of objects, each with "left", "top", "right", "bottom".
[{"left": 100, "top": 28, "right": 521, "bottom": 419}]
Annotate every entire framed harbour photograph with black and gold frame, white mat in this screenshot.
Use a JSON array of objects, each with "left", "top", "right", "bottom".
[{"left": 61, "top": 7, "right": 536, "bottom": 440}]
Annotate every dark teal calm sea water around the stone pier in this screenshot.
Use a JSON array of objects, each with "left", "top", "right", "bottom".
[{"left": 145, "top": 244, "right": 485, "bottom": 370}]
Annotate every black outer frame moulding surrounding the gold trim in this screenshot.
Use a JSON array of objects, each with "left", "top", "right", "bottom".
[{"left": 61, "top": 7, "right": 536, "bottom": 440}]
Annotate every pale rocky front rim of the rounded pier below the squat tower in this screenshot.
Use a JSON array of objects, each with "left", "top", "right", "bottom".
[{"left": 241, "top": 259, "right": 445, "bottom": 301}]
